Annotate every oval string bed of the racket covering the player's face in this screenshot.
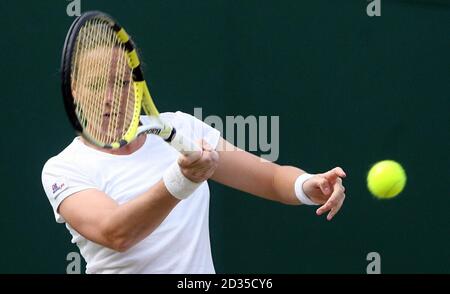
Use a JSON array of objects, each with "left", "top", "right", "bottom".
[{"left": 72, "top": 19, "right": 134, "bottom": 144}]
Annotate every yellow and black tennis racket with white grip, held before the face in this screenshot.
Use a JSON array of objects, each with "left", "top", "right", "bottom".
[{"left": 61, "top": 11, "right": 200, "bottom": 154}]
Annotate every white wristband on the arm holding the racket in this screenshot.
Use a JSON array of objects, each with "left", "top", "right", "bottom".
[{"left": 163, "top": 162, "right": 203, "bottom": 200}]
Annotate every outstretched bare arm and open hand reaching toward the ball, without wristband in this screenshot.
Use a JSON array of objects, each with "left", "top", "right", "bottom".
[{"left": 211, "top": 138, "right": 346, "bottom": 220}]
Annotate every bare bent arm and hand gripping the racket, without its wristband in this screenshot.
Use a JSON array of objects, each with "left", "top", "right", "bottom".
[{"left": 58, "top": 142, "right": 218, "bottom": 252}]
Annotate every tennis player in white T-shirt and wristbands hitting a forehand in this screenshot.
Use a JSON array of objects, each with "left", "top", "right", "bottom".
[{"left": 42, "top": 10, "right": 346, "bottom": 274}]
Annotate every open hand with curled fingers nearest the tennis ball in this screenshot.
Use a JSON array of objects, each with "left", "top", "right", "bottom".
[{"left": 303, "top": 167, "right": 346, "bottom": 220}]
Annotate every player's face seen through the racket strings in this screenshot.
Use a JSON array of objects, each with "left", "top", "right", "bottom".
[{"left": 74, "top": 48, "right": 134, "bottom": 141}]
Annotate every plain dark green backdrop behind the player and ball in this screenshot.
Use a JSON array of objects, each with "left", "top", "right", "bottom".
[{"left": 0, "top": 0, "right": 450, "bottom": 273}]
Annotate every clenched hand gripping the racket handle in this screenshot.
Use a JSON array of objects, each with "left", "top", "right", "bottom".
[{"left": 178, "top": 140, "right": 219, "bottom": 183}]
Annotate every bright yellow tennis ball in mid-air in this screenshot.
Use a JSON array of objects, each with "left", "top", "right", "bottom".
[{"left": 367, "top": 160, "right": 406, "bottom": 199}]
